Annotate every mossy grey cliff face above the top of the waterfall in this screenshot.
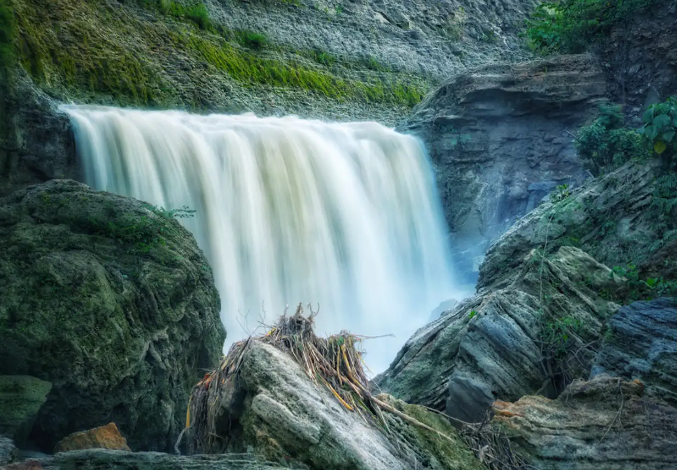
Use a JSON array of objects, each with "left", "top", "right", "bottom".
[{"left": 2, "top": 0, "right": 534, "bottom": 122}]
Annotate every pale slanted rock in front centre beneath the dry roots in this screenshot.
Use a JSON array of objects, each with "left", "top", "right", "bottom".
[{"left": 185, "top": 341, "right": 483, "bottom": 470}]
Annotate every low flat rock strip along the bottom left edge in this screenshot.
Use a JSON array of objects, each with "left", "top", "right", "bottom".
[{"left": 6, "top": 449, "right": 294, "bottom": 470}]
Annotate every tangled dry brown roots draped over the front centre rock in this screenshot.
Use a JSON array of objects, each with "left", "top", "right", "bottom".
[{"left": 185, "top": 304, "right": 460, "bottom": 452}]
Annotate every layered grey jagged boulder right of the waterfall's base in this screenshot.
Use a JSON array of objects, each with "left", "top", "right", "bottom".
[{"left": 374, "top": 247, "right": 624, "bottom": 421}]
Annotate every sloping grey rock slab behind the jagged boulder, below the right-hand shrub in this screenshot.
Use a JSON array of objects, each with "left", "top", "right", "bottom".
[{"left": 478, "top": 162, "right": 677, "bottom": 291}]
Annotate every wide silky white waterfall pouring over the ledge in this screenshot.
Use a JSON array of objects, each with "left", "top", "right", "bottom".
[{"left": 65, "top": 106, "right": 462, "bottom": 371}]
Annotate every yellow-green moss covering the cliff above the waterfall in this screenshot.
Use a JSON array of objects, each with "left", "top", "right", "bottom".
[{"left": 5, "top": 0, "right": 427, "bottom": 110}]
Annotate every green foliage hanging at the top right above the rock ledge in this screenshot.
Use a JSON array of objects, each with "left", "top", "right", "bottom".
[{"left": 522, "top": 0, "right": 655, "bottom": 54}]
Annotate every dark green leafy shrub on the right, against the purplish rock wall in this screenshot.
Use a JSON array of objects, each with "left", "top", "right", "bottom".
[{"left": 576, "top": 106, "right": 650, "bottom": 176}]
